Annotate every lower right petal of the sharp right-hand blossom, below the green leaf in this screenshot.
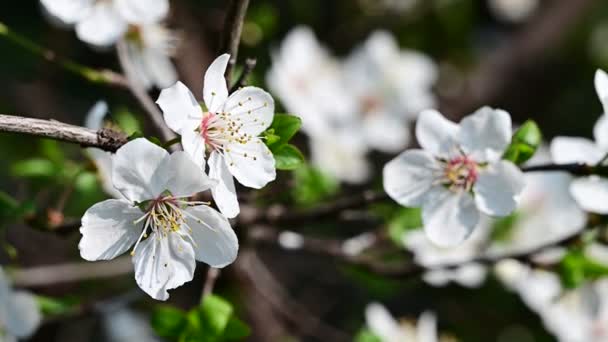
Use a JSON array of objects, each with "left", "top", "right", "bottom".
[{"left": 473, "top": 160, "right": 525, "bottom": 216}]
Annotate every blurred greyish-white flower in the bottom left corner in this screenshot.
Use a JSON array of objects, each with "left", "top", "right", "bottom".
[{"left": 0, "top": 267, "right": 42, "bottom": 341}]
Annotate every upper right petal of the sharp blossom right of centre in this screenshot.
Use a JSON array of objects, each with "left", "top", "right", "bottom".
[{"left": 458, "top": 107, "right": 511, "bottom": 161}]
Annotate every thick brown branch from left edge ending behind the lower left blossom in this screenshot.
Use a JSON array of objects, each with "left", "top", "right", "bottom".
[{"left": 0, "top": 114, "right": 127, "bottom": 152}]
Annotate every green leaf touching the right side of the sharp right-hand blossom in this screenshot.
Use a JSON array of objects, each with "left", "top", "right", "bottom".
[{"left": 502, "top": 120, "right": 543, "bottom": 165}]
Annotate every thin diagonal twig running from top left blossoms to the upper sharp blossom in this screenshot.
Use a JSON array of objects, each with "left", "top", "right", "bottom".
[{"left": 116, "top": 40, "right": 176, "bottom": 147}]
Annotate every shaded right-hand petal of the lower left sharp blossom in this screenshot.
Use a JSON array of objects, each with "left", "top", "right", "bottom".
[{"left": 186, "top": 205, "right": 239, "bottom": 268}]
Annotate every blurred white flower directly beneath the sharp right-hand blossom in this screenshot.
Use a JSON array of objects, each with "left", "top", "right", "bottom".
[{"left": 403, "top": 223, "right": 490, "bottom": 287}]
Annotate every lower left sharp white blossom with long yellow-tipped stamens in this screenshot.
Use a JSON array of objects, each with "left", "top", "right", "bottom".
[{"left": 78, "top": 138, "right": 238, "bottom": 300}]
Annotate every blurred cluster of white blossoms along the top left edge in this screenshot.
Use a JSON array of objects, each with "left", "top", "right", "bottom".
[{"left": 40, "top": 0, "right": 178, "bottom": 88}]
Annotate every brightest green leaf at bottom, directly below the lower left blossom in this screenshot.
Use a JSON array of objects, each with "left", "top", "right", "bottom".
[{"left": 198, "top": 295, "right": 233, "bottom": 336}]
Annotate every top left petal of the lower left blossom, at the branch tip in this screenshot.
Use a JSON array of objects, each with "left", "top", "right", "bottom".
[{"left": 112, "top": 138, "right": 169, "bottom": 202}]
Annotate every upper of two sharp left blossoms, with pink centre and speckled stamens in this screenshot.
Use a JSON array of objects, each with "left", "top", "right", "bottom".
[{"left": 156, "top": 54, "right": 276, "bottom": 218}]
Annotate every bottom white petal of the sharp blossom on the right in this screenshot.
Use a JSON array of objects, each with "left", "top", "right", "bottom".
[{"left": 422, "top": 186, "right": 479, "bottom": 247}]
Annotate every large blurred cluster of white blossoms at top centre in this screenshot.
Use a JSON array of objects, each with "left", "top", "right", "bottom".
[{"left": 266, "top": 27, "right": 437, "bottom": 183}]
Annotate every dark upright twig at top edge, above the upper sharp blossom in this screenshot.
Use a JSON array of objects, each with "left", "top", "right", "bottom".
[{"left": 220, "top": 0, "right": 249, "bottom": 83}]
